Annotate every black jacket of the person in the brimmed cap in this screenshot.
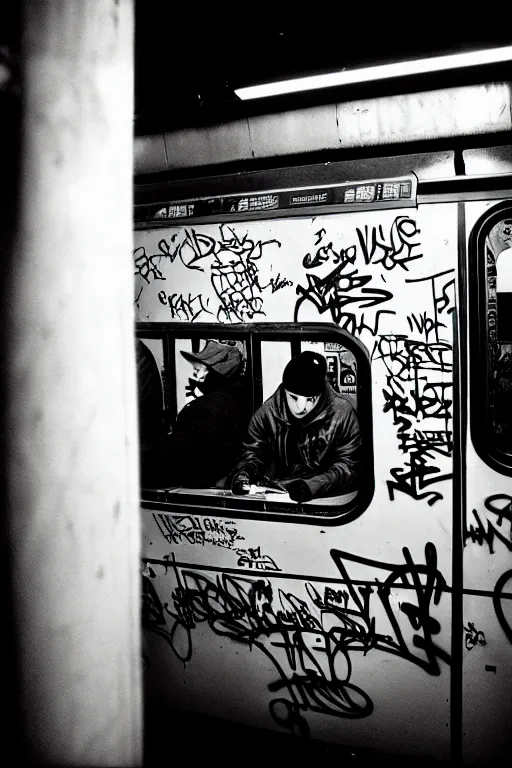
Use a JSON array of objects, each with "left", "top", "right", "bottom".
[{"left": 164, "top": 372, "right": 250, "bottom": 488}]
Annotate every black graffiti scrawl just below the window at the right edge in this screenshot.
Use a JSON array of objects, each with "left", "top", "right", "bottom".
[{"left": 463, "top": 493, "right": 512, "bottom": 555}]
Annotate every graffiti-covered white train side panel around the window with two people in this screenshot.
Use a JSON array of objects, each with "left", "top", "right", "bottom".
[{"left": 134, "top": 179, "right": 472, "bottom": 759}]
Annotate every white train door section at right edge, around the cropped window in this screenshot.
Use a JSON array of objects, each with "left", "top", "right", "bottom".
[{"left": 462, "top": 201, "right": 512, "bottom": 762}]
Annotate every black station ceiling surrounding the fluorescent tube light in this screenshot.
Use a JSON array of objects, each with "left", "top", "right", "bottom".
[{"left": 135, "top": 9, "right": 512, "bottom": 134}]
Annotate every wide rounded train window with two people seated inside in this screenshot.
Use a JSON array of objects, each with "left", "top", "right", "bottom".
[{"left": 137, "top": 323, "right": 374, "bottom": 524}]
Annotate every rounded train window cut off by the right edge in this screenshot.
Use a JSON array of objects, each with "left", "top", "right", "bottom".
[{"left": 469, "top": 202, "right": 512, "bottom": 474}]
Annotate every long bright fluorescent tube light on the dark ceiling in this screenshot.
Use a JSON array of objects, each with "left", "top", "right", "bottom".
[{"left": 235, "top": 46, "right": 512, "bottom": 100}]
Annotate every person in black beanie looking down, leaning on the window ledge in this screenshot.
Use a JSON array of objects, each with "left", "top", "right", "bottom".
[{"left": 231, "top": 351, "right": 361, "bottom": 503}]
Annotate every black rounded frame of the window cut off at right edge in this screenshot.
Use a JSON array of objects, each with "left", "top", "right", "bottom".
[{"left": 468, "top": 200, "right": 512, "bottom": 476}]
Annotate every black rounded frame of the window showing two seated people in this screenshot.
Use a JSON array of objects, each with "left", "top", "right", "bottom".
[{"left": 135, "top": 322, "right": 375, "bottom": 526}]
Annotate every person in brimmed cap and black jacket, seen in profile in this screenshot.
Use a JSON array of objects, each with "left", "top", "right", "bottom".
[{"left": 162, "top": 340, "right": 250, "bottom": 488}]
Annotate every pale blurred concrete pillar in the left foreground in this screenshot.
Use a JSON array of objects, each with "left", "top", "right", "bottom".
[{"left": 6, "top": 0, "right": 142, "bottom": 766}]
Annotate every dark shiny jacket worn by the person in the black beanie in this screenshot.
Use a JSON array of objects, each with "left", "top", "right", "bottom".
[{"left": 233, "top": 384, "right": 361, "bottom": 498}]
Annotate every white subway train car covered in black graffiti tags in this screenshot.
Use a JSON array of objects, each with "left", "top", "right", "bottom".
[{"left": 133, "top": 154, "right": 512, "bottom": 764}]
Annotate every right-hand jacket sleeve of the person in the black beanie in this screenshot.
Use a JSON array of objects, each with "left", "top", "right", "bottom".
[{"left": 305, "top": 403, "right": 361, "bottom": 498}]
